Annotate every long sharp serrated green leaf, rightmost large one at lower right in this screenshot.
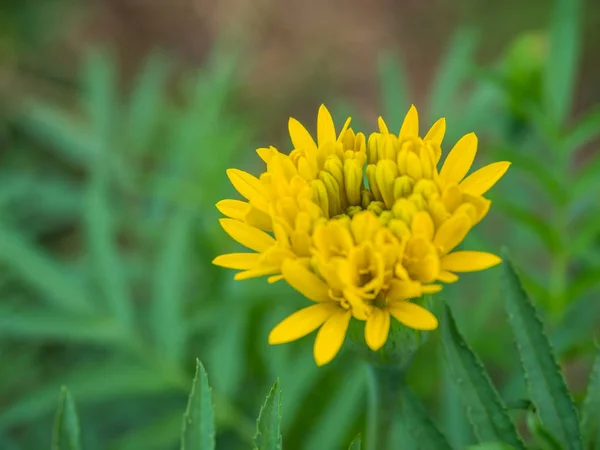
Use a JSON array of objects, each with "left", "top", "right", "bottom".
[{"left": 503, "top": 255, "right": 582, "bottom": 450}]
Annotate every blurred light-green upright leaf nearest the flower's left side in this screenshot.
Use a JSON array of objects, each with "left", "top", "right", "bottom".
[{"left": 152, "top": 210, "right": 192, "bottom": 362}]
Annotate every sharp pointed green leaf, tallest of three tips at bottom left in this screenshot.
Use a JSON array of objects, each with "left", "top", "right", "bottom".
[{"left": 181, "top": 359, "right": 215, "bottom": 450}]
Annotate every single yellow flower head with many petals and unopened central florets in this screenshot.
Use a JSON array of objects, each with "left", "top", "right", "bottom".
[{"left": 213, "top": 106, "right": 510, "bottom": 365}]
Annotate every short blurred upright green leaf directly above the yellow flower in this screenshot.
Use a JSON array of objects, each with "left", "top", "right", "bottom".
[{"left": 379, "top": 54, "right": 410, "bottom": 132}]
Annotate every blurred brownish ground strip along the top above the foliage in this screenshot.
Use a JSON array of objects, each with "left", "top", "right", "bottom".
[{"left": 4, "top": 0, "right": 600, "bottom": 134}]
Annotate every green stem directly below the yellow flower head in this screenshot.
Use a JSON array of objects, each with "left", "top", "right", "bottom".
[{"left": 366, "top": 364, "right": 402, "bottom": 450}]
